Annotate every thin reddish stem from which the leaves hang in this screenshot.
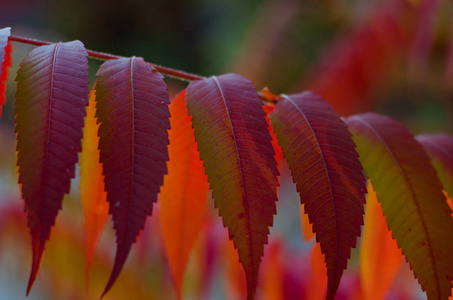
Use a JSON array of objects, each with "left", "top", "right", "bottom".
[{"left": 9, "top": 35, "right": 204, "bottom": 81}]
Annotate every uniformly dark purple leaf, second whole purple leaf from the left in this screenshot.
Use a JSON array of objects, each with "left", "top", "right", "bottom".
[{"left": 96, "top": 57, "right": 170, "bottom": 296}]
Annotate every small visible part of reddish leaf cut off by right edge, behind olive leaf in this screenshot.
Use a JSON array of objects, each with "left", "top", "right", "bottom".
[{"left": 415, "top": 133, "right": 453, "bottom": 198}]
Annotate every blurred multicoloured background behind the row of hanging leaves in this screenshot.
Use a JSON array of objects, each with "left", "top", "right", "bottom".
[{"left": 0, "top": 0, "right": 453, "bottom": 299}]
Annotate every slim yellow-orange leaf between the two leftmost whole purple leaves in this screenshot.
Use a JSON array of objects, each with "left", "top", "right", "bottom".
[{"left": 80, "top": 85, "right": 109, "bottom": 288}]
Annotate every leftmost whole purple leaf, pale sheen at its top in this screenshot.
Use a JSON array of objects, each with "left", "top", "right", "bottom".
[{"left": 15, "top": 41, "right": 88, "bottom": 294}]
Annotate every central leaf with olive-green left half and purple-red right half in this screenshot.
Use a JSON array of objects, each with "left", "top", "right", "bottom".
[{"left": 187, "top": 74, "right": 278, "bottom": 299}]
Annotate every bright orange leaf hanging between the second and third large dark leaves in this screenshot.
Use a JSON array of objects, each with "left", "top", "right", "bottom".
[{"left": 159, "top": 91, "right": 209, "bottom": 298}]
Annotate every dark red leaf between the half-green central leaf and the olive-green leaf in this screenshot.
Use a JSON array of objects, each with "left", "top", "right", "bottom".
[{"left": 271, "top": 92, "right": 366, "bottom": 299}]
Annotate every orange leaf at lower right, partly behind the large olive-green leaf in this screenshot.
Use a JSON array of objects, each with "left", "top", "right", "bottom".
[{"left": 359, "top": 181, "right": 403, "bottom": 300}]
